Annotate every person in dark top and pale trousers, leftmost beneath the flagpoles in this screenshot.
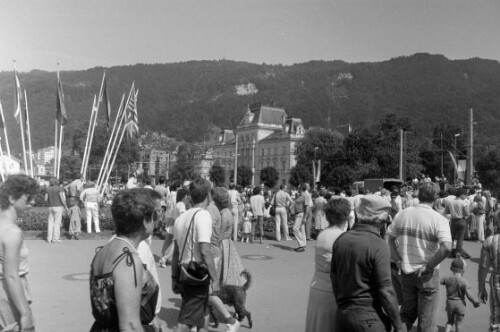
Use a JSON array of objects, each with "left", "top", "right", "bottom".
[{"left": 45, "top": 178, "right": 68, "bottom": 243}]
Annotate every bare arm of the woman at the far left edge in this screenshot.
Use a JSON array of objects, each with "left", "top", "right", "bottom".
[{"left": 2, "top": 227, "right": 35, "bottom": 331}]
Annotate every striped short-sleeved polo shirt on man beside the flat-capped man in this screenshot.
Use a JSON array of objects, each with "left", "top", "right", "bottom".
[{"left": 387, "top": 204, "right": 451, "bottom": 273}]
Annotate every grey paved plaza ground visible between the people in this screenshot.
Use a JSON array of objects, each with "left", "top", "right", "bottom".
[{"left": 26, "top": 236, "right": 489, "bottom": 332}]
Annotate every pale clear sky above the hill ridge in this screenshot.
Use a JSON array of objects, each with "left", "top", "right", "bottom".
[{"left": 0, "top": 0, "right": 500, "bottom": 71}]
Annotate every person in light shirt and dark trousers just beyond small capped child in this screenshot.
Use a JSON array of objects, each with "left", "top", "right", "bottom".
[{"left": 444, "top": 188, "right": 470, "bottom": 258}]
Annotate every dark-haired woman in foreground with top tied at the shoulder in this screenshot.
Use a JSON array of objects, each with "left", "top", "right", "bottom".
[{"left": 90, "top": 188, "right": 161, "bottom": 332}]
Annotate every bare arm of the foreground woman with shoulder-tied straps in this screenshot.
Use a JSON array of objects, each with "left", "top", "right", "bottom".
[{"left": 113, "top": 256, "right": 144, "bottom": 332}]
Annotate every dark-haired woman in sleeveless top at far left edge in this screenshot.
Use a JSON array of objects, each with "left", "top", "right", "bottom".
[{"left": 0, "top": 174, "right": 38, "bottom": 332}]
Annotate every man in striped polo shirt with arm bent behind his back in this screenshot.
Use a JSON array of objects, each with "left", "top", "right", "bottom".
[{"left": 387, "top": 182, "right": 452, "bottom": 332}]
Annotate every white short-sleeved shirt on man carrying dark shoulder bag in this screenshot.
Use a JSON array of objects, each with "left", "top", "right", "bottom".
[{"left": 173, "top": 208, "right": 212, "bottom": 264}]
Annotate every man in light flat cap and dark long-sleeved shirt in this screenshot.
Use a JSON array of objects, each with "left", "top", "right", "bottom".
[{"left": 330, "top": 195, "right": 404, "bottom": 332}]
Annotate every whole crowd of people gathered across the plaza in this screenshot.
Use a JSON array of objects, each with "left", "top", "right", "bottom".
[{"left": 0, "top": 175, "right": 500, "bottom": 332}]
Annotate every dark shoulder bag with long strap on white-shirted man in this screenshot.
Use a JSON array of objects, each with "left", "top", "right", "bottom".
[{"left": 179, "top": 210, "right": 210, "bottom": 286}]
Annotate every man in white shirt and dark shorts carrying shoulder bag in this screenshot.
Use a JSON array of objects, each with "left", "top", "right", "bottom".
[{"left": 172, "top": 179, "right": 239, "bottom": 332}]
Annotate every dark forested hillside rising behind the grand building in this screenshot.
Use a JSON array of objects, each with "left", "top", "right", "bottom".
[{"left": 0, "top": 54, "right": 500, "bottom": 152}]
